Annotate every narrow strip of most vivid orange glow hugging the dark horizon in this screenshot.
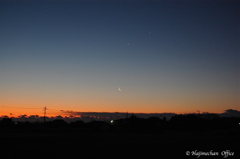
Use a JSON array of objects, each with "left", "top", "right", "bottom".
[{"left": 0, "top": 101, "right": 234, "bottom": 117}]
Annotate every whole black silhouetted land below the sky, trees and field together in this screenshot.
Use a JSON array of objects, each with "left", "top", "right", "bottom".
[{"left": 0, "top": 110, "right": 240, "bottom": 159}]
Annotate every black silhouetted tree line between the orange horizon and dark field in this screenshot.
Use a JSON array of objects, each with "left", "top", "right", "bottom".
[{"left": 0, "top": 114, "right": 240, "bottom": 132}]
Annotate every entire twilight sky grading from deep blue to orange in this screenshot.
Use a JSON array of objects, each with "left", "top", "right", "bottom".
[{"left": 0, "top": 0, "right": 240, "bottom": 115}]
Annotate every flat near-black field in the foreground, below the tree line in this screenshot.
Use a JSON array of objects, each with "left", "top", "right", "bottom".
[{"left": 0, "top": 130, "right": 240, "bottom": 159}]
